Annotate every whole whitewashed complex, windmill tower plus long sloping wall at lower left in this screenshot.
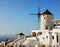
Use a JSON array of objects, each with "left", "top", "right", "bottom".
[{"left": 12, "top": 10, "right": 60, "bottom": 47}]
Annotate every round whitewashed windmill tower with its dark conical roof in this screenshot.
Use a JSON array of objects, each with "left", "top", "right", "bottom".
[{"left": 40, "top": 9, "right": 53, "bottom": 30}]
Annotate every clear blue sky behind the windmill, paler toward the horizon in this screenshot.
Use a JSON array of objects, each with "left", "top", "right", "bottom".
[{"left": 0, "top": 0, "right": 60, "bottom": 34}]
